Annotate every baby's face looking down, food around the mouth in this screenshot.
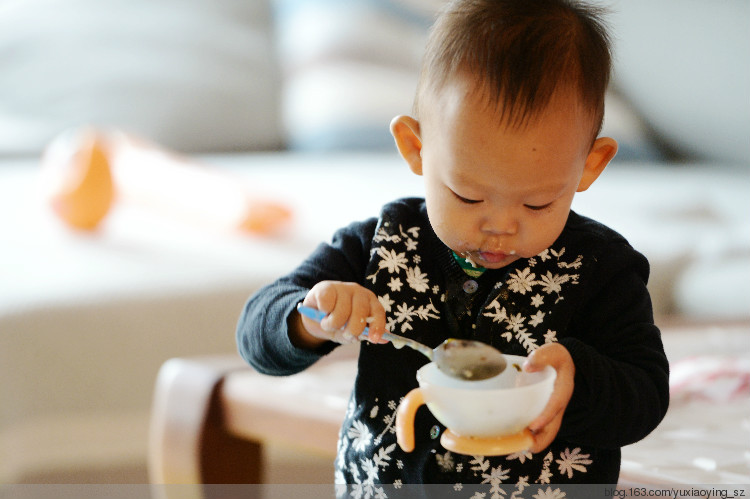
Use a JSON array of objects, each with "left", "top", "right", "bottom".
[{"left": 417, "top": 79, "right": 604, "bottom": 268}]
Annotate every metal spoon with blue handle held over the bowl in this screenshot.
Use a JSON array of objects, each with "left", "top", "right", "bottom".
[{"left": 297, "top": 303, "right": 507, "bottom": 381}]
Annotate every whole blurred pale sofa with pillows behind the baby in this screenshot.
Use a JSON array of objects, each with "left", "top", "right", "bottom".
[{"left": 0, "top": 0, "right": 750, "bottom": 483}]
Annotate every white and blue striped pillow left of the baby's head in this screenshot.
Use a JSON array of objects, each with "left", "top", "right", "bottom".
[{"left": 273, "top": 0, "right": 443, "bottom": 151}]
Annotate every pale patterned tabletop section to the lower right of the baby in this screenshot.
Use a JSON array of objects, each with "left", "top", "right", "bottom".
[{"left": 620, "top": 324, "right": 750, "bottom": 488}]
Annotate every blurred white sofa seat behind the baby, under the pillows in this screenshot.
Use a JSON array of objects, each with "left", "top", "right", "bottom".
[{"left": 0, "top": 153, "right": 750, "bottom": 317}]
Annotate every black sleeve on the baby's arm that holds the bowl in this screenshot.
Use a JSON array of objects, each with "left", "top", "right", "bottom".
[{"left": 560, "top": 242, "right": 669, "bottom": 448}]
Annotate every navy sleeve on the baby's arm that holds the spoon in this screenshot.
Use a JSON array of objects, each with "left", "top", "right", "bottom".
[{"left": 236, "top": 219, "right": 376, "bottom": 376}]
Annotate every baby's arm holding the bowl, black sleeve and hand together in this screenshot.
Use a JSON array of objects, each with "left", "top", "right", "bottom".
[{"left": 524, "top": 238, "right": 669, "bottom": 453}]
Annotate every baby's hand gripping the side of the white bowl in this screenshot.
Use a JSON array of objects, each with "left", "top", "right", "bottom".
[{"left": 524, "top": 343, "right": 576, "bottom": 453}]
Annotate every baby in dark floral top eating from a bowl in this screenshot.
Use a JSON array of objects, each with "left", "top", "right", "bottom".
[{"left": 237, "top": 0, "right": 669, "bottom": 495}]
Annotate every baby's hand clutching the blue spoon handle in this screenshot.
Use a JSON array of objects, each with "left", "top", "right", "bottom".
[{"left": 302, "top": 281, "right": 386, "bottom": 343}]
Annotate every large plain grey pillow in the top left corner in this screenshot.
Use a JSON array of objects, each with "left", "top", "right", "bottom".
[{"left": 0, "top": 0, "right": 282, "bottom": 154}]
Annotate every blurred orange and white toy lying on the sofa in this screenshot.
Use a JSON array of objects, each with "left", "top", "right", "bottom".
[{"left": 42, "top": 128, "right": 291, "bottom": 235}]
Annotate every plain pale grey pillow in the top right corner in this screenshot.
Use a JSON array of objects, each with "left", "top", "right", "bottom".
[{"left": 611, "top": 0, "right": 750, "bottom": 166}]
